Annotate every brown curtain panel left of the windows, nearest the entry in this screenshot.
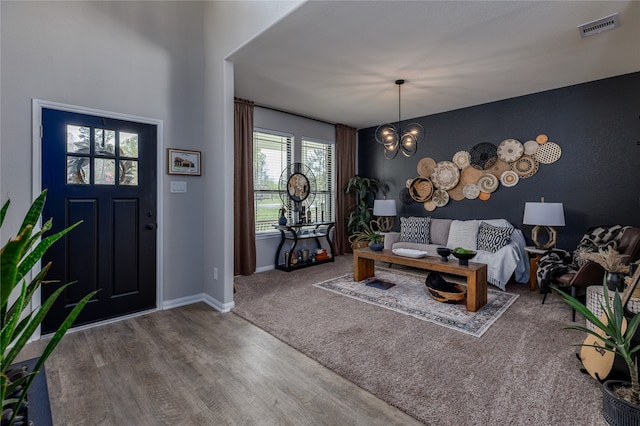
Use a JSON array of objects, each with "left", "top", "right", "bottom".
[{"left": 233, "top": 98, "right": 256, "bottom": 275}]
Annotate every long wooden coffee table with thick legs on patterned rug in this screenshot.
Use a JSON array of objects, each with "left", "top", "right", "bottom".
[{"left": 353, "top": 247, "right": 487, "bottom": 312}]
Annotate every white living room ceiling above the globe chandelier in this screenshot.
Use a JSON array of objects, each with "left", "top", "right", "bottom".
[{"left": 229, "top": 1, "right": 640, "bottom": 128}]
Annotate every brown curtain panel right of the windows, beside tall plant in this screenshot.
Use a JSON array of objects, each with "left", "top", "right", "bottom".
[{"left": 334, "top": 124, "right": 357, "bottom": 254}]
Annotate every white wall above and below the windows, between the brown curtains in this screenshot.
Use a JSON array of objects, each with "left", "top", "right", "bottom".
[{"left": 253, "top": 107, "right": 336, "bottom": 272}]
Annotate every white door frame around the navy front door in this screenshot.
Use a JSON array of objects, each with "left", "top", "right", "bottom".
[{"left": 31, "top": 98, "right": 164, "bottom": 340}]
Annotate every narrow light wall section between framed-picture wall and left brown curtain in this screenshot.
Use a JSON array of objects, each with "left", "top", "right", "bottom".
[{"left": 203, "top": 1, "right": 302, "bottom": 308}]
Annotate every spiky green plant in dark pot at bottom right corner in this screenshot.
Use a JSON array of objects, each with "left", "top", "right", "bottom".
[{"left": 554, "top": 282, "right": 640, "bottom": 425}]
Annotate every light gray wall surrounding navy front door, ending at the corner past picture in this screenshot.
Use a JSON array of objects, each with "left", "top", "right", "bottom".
[{"left": 0, "top": 1, "right": 205, "bottom": 306}]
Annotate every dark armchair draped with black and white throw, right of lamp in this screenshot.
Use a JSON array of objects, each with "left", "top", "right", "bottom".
[{"left": 537, "top": 225, "right": 640, "bottom": 321}]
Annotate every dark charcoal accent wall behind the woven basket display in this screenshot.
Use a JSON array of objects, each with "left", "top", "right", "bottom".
[{"left": 358, "top": 72, "right": 640, "bottom": 249}]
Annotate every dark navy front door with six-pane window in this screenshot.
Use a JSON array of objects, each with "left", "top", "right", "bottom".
[{"left": 42, "top": 108, "right": 157, "bottom": 334}]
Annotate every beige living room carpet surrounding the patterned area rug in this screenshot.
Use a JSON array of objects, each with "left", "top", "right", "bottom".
[{"left": 233, "top": 255, "right": 605, "bottom": 425}]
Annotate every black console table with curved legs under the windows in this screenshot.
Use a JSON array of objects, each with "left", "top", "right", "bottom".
[{"left": 274, "top": 222, "right": 335, "bottom": 272}]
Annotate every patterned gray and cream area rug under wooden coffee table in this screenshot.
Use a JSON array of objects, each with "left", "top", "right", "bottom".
[{"left": 313, "top": 268, "right": 518, "bottom": 337}]
